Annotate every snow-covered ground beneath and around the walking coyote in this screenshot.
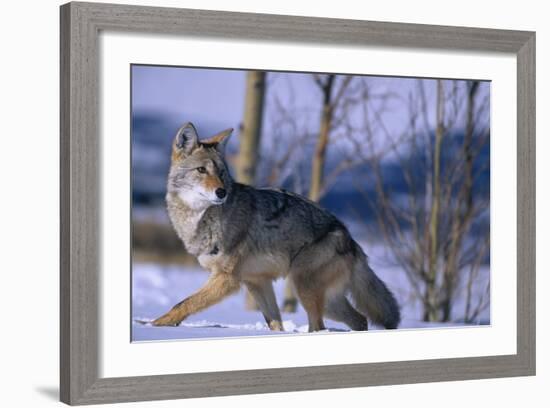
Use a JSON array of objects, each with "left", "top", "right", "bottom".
[{"left": 132, "top": 242, "right": 489, "bottom": 341}]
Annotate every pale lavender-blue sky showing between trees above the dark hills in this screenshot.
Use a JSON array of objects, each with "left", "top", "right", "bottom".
[{"left": 132, "top": 65, "right": 489, "bottom": 146}]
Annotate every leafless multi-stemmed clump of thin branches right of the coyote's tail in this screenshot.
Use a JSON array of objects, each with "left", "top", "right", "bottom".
[{"left": 356, "top": 81, "right": 489, "bottom": 321}]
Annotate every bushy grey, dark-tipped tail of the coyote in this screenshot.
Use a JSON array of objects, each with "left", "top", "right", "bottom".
[{"left": 350, "top": 245, "right": 401, "bottom": 329}]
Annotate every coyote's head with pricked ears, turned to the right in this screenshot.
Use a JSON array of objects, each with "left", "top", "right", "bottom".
[{"left": 167, "top": 123, "right": 233, "bottom": 210}]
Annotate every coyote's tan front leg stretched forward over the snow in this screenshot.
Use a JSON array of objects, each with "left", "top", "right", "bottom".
[{"left": 153, "top": 273, "right": 240, "bottom": 326}]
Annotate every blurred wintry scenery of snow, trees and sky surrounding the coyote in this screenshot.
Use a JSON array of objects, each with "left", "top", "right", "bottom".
[{"left": 131, "top": 65, "right": 490, "bottom": 340}]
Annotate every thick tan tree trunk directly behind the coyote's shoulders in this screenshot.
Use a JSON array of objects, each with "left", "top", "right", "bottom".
[{"left": 236, "top": 71, "right": 266, "bottom": 310}]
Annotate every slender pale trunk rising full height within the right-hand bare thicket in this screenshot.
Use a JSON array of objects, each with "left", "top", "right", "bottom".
[{"left": 424, "top": 80, "right": 445, "bottom": 322}]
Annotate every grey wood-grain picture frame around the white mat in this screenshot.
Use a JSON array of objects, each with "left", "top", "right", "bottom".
[{"left": 60, "top": 3, "right": 535, "bottom": 405}]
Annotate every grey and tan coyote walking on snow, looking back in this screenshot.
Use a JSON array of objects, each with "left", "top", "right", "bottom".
[{"left": 152, "top": 123, "right": 400, "bottom": 332}]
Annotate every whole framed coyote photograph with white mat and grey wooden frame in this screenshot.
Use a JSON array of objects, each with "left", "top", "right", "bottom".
[{"left": 60, "top": 3, "right": 535, "bottom": 405}]
